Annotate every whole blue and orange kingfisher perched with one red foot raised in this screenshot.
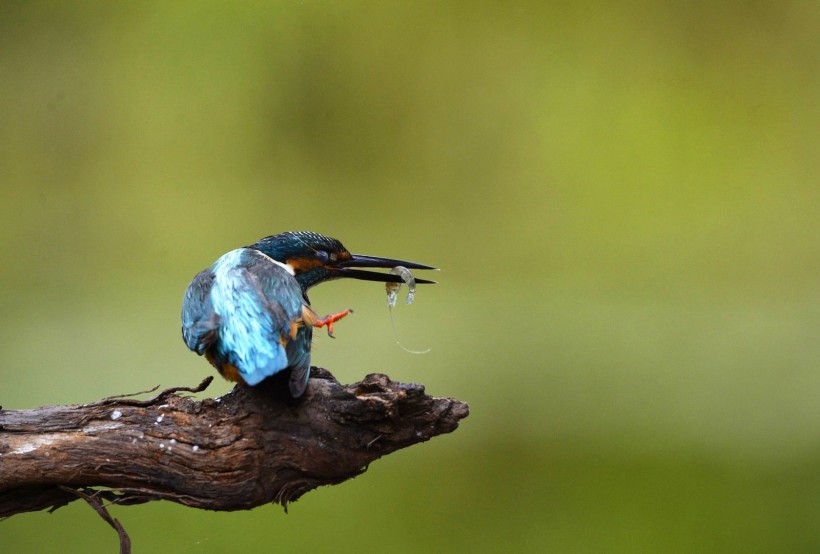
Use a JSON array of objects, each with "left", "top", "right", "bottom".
[{"left": 182, "top": 231, "right": 436, "bottom": 398}]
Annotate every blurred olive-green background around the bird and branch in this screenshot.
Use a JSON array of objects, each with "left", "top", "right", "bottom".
[{"left": 0, "top": 1, "right": 820, "bottom": 553}]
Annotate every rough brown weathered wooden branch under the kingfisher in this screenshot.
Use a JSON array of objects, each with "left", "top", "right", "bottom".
[{"left": 0, "top": 368, "right": 469, "bottom": 516}]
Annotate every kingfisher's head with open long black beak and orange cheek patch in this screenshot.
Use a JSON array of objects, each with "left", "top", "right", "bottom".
[{"left": 250, "top": 231, "right": 436, "bottom": 291}]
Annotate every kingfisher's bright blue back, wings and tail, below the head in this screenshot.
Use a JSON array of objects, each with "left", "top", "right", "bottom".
[{"left": 183, "top": 248, "right": 312, "bottom": 397}]
